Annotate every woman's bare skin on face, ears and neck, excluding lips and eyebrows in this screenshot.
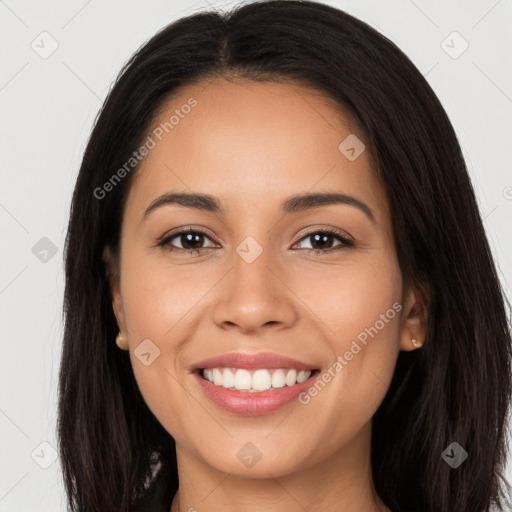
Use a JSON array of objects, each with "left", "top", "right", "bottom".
[{"left": 107, "top": 78, "right": 426, "bottom": 512}]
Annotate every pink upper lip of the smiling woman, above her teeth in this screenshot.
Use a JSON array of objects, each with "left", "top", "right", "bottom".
[{"left": 192, "top": 352, "right": 315, "bottom": 371}]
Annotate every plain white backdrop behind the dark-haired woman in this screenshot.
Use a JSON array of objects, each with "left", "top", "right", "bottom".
[{"left": 0, "top": 0, "right": 512, "bottom": 512}]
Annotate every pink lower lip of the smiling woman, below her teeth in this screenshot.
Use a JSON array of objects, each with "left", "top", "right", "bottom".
[{"left": 194, "top": 371, "right": 317, "bottom": 416}]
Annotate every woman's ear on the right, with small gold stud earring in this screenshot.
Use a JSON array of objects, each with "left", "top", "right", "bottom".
[{"left": 400, "top": 282, "right": 429, "bottom": 352}]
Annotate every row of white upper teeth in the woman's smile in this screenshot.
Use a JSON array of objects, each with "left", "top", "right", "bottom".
[{"left": 203, "top": 368, "right": 311, "bottom": 393}]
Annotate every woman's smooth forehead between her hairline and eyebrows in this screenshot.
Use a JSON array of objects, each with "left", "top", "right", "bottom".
[{"left": 122, "top": 78, "right": 379, "bottom": 218}]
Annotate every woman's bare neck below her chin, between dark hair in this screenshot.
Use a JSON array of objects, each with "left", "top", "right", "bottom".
[{"left": 170, "top": 425, "right": 389, "bottom": 512}]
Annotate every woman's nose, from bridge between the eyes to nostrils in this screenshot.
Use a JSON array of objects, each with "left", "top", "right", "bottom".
[{"left": 213, "top": 242, "right": 298, "bottom": 334}]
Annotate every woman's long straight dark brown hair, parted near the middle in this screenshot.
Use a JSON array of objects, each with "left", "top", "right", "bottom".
[{"left": 57, "top": 0, "right": 511, "bottom": 512}]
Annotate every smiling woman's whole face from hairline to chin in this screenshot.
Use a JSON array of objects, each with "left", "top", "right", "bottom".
[{"left": 107, "top": 79, "right": 422, "bottom": 477}]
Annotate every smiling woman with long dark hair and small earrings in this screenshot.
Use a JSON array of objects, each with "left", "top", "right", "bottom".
[{"left": 59, "top": 1, "right": 511, "bottom": 512}]
